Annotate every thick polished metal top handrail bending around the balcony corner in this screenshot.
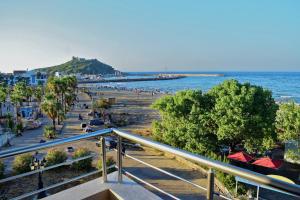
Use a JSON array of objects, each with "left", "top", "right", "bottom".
[{"left": 0, "top": 128, "right": 300, "bottom": 197}]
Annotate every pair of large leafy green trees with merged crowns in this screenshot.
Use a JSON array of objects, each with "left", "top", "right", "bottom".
[{"left": 153, "top": 80, "right": 277, "bottom": 154}]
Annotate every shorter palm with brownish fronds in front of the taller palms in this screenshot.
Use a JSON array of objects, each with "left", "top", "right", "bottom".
[{"left": 41, "top": 93, "right": 61, "bottom": 130}]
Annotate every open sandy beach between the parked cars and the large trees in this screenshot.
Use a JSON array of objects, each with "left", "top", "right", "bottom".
[{"left": 85, "top": 87, "right": 166, "bottom": 133}]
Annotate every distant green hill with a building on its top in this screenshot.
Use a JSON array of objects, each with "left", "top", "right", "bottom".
[{"left": 35, "top": 57, "right": 120, "bottom": 75}]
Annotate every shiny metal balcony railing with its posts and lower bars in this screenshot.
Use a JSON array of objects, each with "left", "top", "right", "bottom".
[{"left": 0, "top": 129, "right": 300, "bottom": 199}]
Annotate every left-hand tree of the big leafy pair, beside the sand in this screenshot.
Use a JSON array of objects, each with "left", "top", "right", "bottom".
[{"left": 153, "top": 90, "right": 218, "bottom": 154}]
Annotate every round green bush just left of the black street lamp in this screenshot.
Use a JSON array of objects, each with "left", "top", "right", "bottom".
[{"left": 13, "top": 154, "right": 32, "bottom": 174}]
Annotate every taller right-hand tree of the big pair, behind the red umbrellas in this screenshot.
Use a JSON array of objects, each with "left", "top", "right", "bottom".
[{"left": 208, "top": 80, "right": 278, "bottom": 152}]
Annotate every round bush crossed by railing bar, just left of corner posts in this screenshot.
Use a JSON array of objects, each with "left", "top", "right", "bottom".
[{"left": 72, "top": 148, "right": 93, "bottom": 170}]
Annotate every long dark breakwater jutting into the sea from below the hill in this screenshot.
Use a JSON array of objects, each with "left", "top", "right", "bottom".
[{"left": 78, "top": 76, "right": 186, "bottom": 84}]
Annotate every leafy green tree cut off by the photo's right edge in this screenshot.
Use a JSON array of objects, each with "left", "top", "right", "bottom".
[{"left": 275, "top": 102, "right": 300, "bottom": 142}]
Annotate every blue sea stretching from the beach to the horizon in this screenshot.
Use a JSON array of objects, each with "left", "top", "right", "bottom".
[{"left": 100, "top": 72, "right": 300, "bottom": 103}]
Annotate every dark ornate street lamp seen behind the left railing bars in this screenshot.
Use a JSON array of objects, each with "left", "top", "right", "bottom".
[{"left": 30, "top": 152, "right": 47, "bottom": 199}]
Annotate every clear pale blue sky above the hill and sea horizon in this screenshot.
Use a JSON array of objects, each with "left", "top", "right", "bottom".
[{"left": 0, "top": 0, "right": 300, "bottom": 72}]
